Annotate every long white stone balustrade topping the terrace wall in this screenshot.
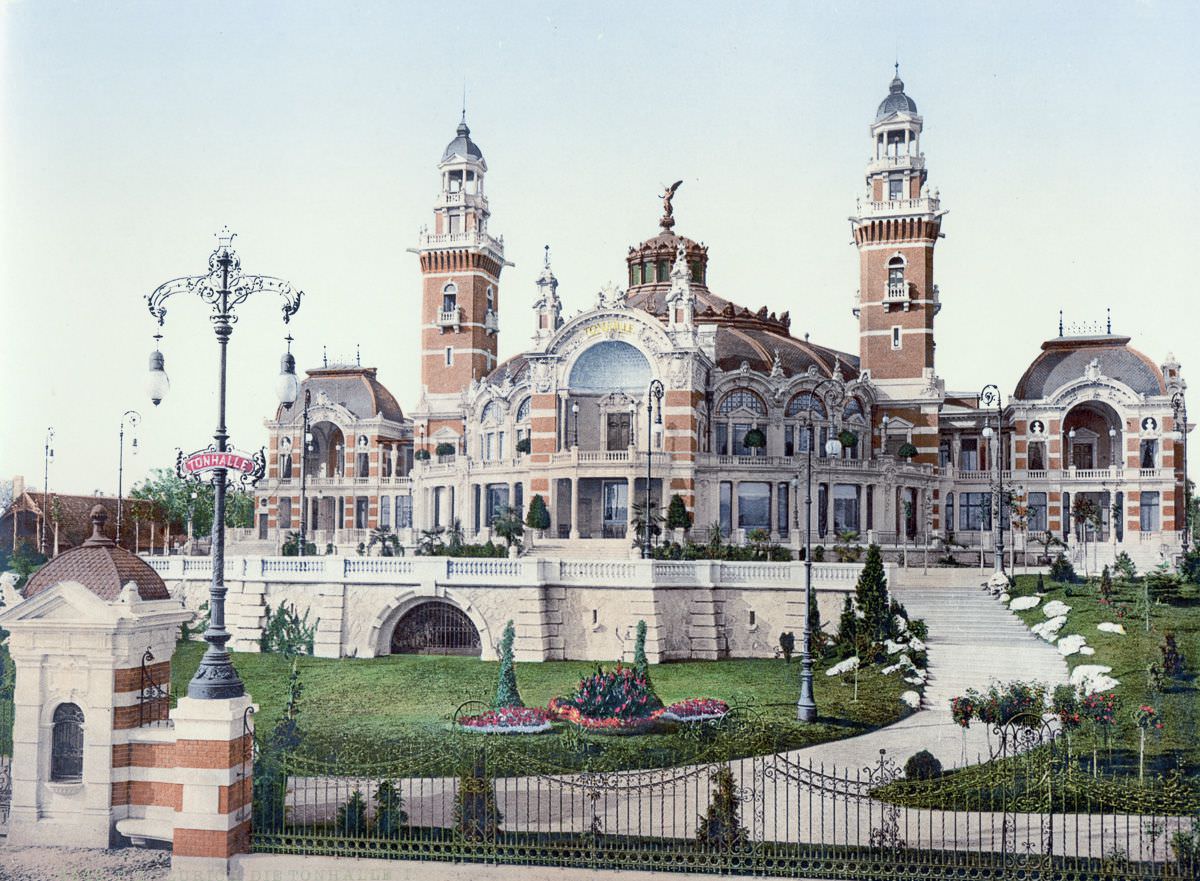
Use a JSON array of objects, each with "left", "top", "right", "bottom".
[{"left": 144, "top": 556, "right": 894, "bottom": 588}]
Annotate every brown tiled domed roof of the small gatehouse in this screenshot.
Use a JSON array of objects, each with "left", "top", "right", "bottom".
[{"left": 25, "top": 505, "right": 170, "bottom": 603}]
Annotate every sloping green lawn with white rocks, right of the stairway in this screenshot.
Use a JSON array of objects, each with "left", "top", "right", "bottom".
[{"left": 1014, "top": 575, "right": 1200, "bottom": 775}]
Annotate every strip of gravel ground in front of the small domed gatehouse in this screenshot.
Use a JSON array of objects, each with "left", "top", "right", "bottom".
[{"left": 0, "top": 844, "right": 170, "bottom": 881}]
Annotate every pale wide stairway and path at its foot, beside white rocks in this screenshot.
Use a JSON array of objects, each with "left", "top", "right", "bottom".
[{"left": 797, "top": 583, "right": 1068, "bottom": 769}]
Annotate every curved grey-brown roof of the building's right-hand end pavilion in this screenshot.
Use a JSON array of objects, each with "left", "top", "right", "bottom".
[{"left": 1013, "top": 334, "right": 1166, "bottom": 401}]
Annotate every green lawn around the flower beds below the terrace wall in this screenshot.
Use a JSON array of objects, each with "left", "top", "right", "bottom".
[{"left": 172, "top": 642, "right": 910, "bottom": 773}]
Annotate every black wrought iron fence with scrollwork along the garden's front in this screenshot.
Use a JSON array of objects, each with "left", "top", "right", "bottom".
[{"left": 252, "top": 714, "right": 1200, "bottom": 881}]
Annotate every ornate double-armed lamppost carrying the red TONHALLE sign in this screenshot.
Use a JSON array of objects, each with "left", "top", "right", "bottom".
[{"left": 146, "top": 228, "right": 304, "bottom": 700}]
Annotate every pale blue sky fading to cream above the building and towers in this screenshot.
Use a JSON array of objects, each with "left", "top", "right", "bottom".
[{"left": 0, "top": 1, "right": 1200, "bottom": 492}]
